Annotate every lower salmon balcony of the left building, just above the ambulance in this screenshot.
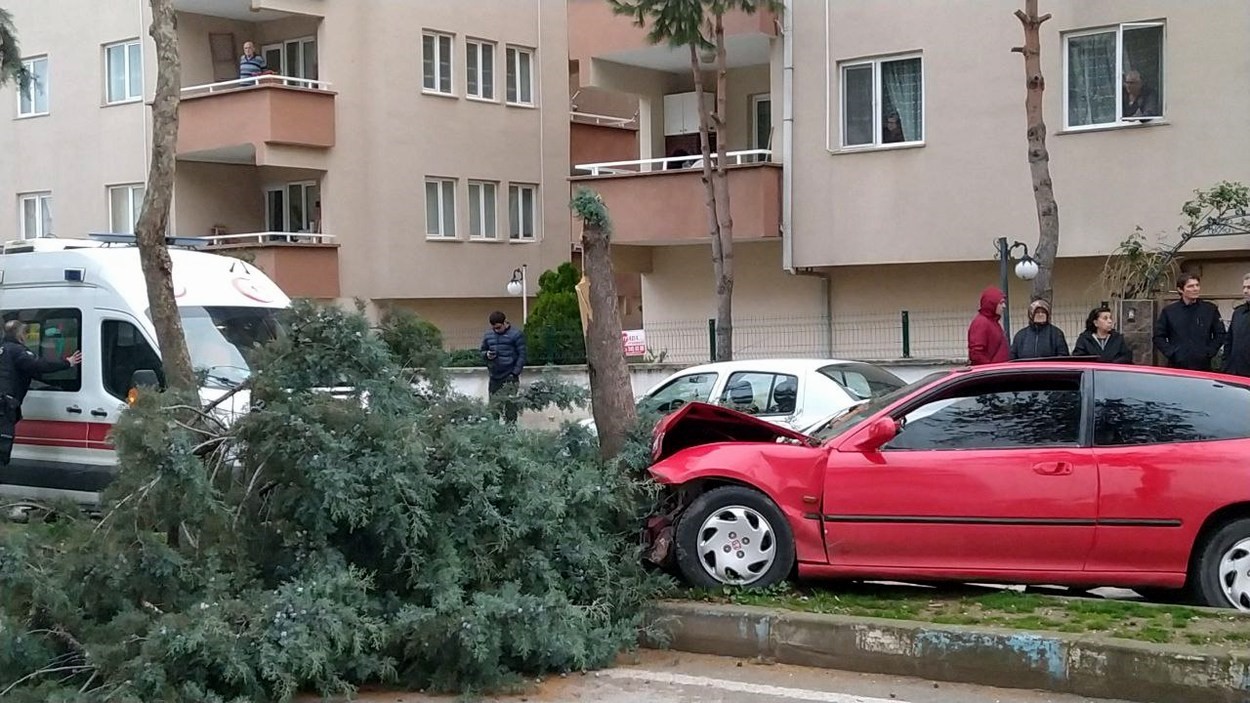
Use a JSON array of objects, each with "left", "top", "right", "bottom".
[{"left": 204, "top": 231, "right": 339, "bottom": 300}]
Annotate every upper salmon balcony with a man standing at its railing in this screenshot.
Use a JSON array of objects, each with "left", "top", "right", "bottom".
[{"left": 178, "top": 75, "right": 335, "bottom": 170}]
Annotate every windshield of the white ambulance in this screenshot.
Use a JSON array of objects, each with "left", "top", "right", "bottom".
[{"left": 179, "top": 306, "right": 279, "bottom": 388}]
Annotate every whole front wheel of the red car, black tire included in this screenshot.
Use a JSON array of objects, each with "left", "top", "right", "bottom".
[{"left": 676, "top": 485, "right": 794, "bottom": 588}]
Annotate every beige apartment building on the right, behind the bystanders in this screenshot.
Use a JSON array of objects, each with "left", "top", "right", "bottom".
[{"left": 569, "top": 0, "right": 1250, "bottom": 357}]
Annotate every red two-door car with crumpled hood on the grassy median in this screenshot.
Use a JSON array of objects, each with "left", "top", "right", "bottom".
[{"left": 648, "top": 359, "right": 1250, "bottom": 610}]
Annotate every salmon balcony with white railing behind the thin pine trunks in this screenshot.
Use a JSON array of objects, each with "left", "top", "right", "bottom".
[{"left": 570, "top": 149, "right": 781, "bottom": 245}]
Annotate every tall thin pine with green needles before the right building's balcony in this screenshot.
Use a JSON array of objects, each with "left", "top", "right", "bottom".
[{"left": 608, "top": 0, "right": 784, "bottom": 362}]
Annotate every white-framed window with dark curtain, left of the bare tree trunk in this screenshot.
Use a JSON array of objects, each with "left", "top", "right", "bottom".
[{"left": 841, "top": 56, "right": 925, "bottom": 146}]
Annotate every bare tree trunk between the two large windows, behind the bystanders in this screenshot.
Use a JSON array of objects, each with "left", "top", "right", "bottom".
[{"left": 1013, "top": 0, "right": 1059, "bottom": 300}]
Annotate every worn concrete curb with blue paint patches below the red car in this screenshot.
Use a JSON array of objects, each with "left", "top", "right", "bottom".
[{"left": 643, "top": 602, "right": 1250, "bottom": 703}]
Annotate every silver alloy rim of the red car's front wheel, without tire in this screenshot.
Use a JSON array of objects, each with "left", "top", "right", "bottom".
[{"left": 696, "top": 505, "right": 776, "bottom": 585}]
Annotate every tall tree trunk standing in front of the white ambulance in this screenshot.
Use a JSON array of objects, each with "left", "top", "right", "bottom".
[{"left": 135, "top": 0, "right": 196, "bottom": 390}]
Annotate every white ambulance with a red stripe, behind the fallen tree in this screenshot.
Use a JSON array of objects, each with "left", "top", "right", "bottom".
[{"left": 0, "top": 234, "right": 290, "bottom": 505}]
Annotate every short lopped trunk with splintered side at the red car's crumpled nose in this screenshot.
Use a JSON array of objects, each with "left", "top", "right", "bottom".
[{"left": 573, "top": 188, "right": 638, "bottom": 458}]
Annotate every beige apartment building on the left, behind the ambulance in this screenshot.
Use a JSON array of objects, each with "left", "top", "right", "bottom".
[{"left": 0, "top": 0, "right": 570, "bottom": 335}]
